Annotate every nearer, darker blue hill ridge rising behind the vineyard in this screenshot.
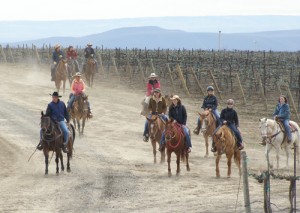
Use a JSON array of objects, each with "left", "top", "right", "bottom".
[{"left": 5, "top": 26, "right": 300, "bottom": 51}]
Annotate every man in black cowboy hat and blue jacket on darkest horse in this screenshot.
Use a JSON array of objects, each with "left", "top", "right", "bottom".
[{"left": 36, "top": 92, "right": 70, "bottom": 153}]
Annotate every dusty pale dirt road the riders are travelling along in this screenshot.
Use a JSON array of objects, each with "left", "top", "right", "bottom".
[{"left": 0, "top": 65, "right": 296, "bottom": 213}]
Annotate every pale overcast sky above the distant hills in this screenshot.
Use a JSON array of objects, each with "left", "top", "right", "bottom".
[{"left": 0, "top": 0, "right": 300, "bottom": 21}]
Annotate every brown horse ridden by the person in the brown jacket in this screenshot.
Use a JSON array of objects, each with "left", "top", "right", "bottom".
[{"left": 146, "top": 115, "right": 166, "bottom": 163}]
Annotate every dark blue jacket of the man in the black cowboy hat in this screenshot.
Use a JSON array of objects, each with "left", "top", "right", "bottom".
[{"left": 46, "top": 99, "right": 70, "bottom": 122}]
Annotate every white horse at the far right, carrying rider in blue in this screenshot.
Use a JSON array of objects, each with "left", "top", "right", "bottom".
[{"left": 259, "top": 118, "right": 300, "bottom": 170}]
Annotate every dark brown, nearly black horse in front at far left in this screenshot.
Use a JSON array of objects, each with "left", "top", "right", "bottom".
[{"left": 41, "top": 111, "right": 75, "bottom": 175}]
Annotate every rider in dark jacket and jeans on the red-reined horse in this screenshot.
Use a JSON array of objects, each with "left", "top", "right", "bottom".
[{"left": 159, "top": 95, "right": 192, "bottom": 153}]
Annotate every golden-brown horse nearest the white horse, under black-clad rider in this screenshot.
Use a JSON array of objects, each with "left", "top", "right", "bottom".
[{"left": 213, "top": 125, "right": 241, "bottom": 178}]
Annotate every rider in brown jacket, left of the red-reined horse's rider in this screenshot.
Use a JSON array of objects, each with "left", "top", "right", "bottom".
[{"left": 143, "top": 88, "right": 167, "bottom": 142}]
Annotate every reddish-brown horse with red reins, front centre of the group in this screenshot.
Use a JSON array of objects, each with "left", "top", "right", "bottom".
[{"left": 165, "top": 119, "right": 190, "bottom": 177}]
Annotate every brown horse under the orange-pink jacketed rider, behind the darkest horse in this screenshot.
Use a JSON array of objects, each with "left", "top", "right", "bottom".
[{"left": 70, "top": 95, "right": 88, "bottom": 135}]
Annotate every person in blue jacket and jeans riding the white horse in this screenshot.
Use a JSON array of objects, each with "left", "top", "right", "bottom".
[{"left": 273, "top": 95, "right": 292, "bottom": 144}]
